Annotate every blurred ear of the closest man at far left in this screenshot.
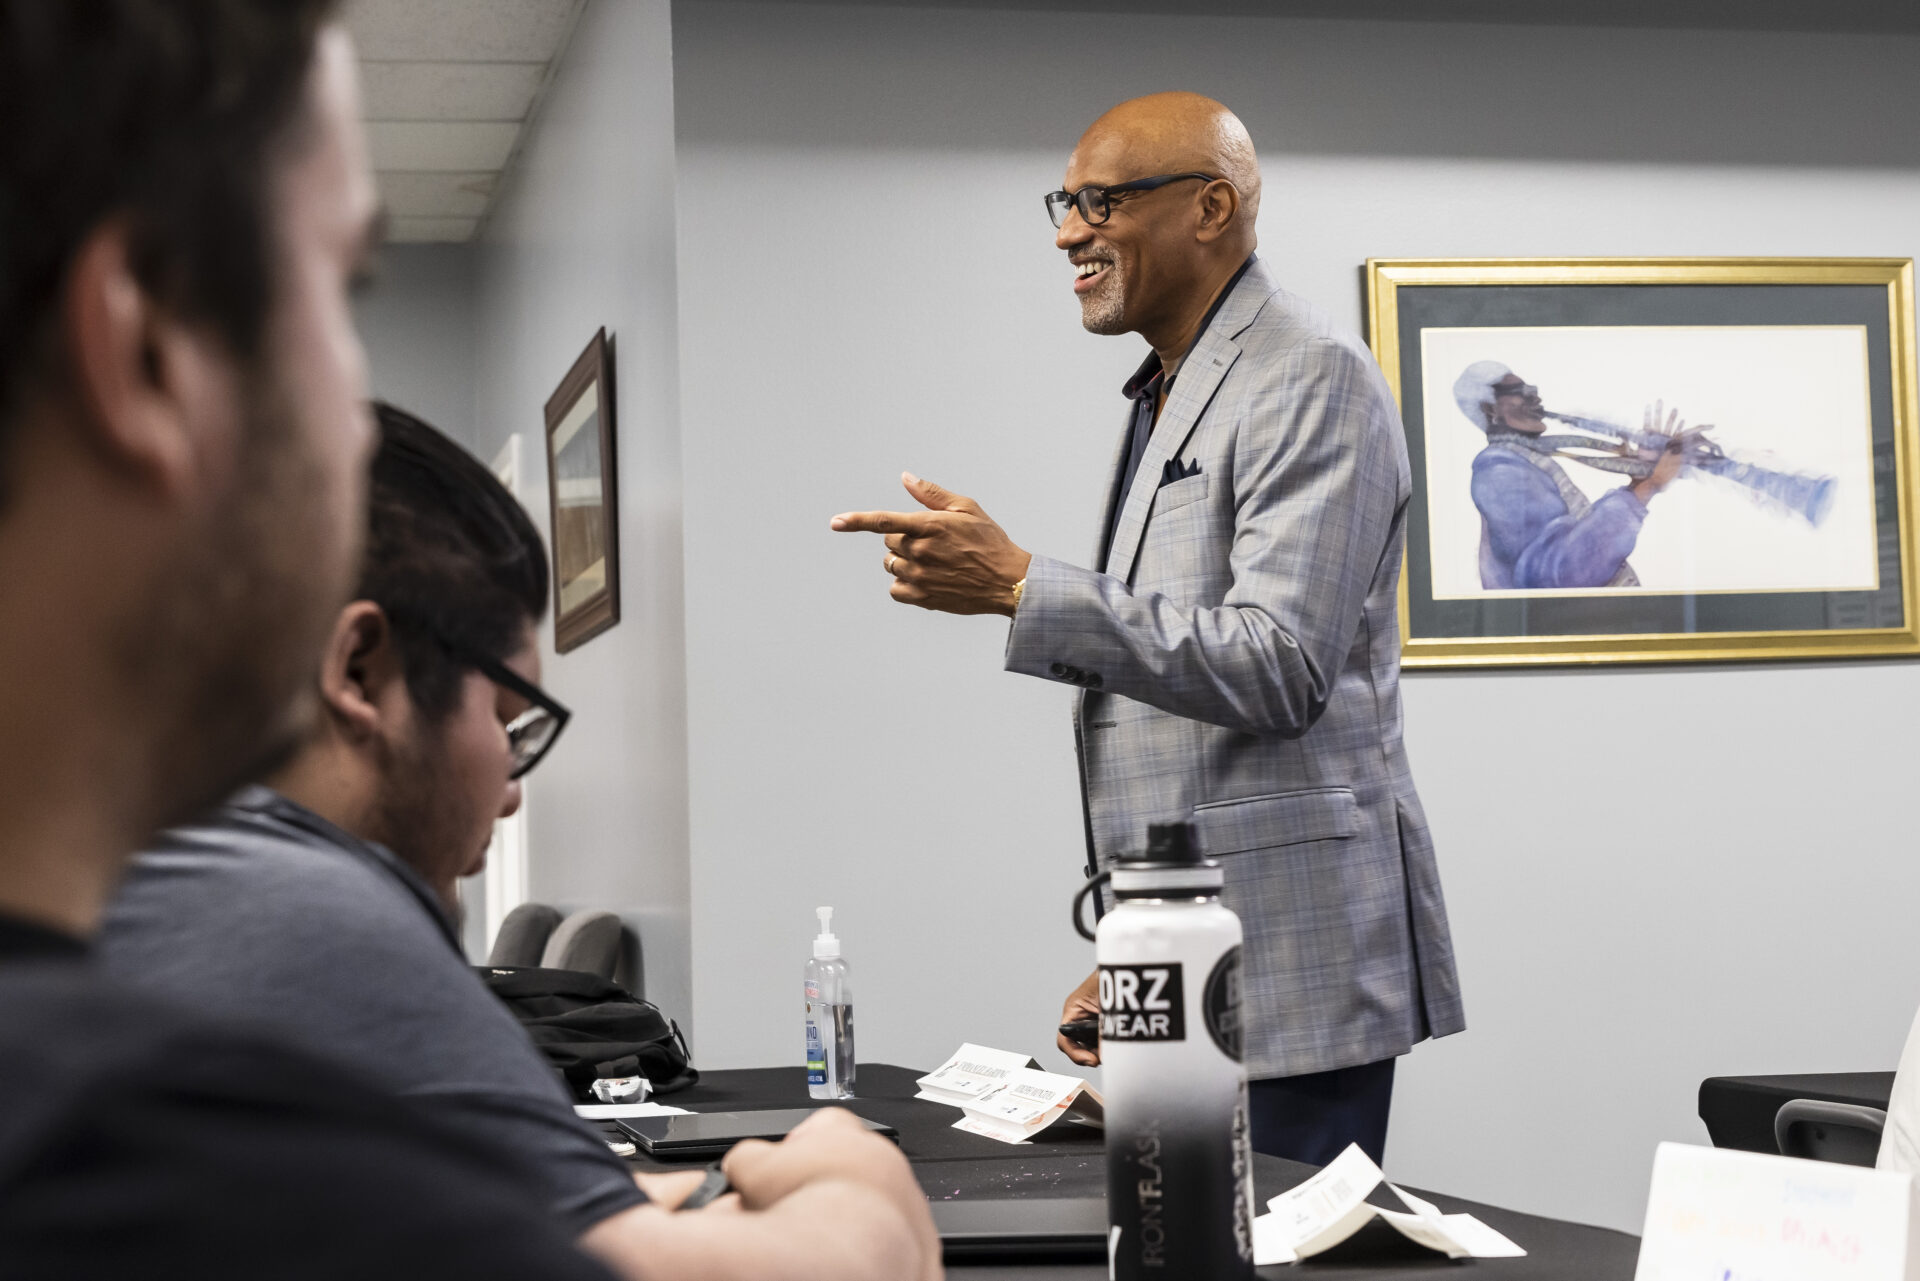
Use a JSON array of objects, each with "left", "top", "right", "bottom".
[{"left": 60, "top": 219, "right": 242, "bottom": 503}]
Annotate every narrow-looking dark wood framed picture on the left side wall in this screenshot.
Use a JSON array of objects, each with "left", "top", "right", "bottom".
[{"left": 547, "top": 328, "right": 620, "bottom": 653}]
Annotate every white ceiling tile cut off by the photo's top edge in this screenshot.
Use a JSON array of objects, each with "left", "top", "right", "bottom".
[{"left": 348, "top": 0, "right": 582, "bottom": 63}]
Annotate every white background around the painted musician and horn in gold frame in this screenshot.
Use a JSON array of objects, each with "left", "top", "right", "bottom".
[{"left": 1421, "top": 325, "right": 1880, "bottom": 599}]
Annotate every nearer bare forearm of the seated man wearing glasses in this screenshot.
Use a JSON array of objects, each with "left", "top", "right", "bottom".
[{"left": 580, "top": 1179, "right": 939, "bottom": 1281}]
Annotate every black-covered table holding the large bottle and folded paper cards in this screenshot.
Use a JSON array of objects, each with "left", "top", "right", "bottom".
[{"left": 634, "top": 1064, "right": 1640, "bottom": 1281}]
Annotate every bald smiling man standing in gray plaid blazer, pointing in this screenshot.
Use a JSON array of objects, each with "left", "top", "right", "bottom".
[{"left": 833, "top": 94, "right": 1465, "bottom": 1164}]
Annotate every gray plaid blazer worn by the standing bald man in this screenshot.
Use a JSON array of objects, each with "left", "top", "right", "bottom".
[{"left": 1006, "top": 261, "right": 1465, "bottom": 1079}]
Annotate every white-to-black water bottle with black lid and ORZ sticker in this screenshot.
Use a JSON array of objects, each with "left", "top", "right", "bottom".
[{"left": 1094, "top": 822, "right": 1254, "bottom": 1281}]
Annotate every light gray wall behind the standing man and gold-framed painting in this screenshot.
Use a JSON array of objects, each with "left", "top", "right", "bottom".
[{"left": 672, "top": 2, "right": 1920, "bottom": 1229}]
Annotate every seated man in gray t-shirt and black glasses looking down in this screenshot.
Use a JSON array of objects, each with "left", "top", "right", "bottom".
[{"left": 100, "top": 405, "right": 939, "bottom": 1279}]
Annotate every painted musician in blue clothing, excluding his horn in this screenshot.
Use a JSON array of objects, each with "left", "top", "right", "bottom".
[{"left": 1453, "top": 361, "right": 1684, "bottom": 590}]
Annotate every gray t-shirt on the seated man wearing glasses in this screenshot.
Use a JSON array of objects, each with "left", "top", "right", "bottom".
[{"left": 98, "top": 787, "right": 645, "bottom": 1233}]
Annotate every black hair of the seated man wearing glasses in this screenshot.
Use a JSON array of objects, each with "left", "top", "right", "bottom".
[{"left": 355, "top": 401, "right": 547, "bottom": 720}]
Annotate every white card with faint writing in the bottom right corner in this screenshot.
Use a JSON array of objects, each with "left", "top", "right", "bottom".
[{"left": 1634, "top": 1143, "right": 1920, "bottom": 1281}]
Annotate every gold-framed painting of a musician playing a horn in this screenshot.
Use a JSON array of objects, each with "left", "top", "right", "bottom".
[{"left": 1367, "top": 257, "right": 1920, "bottom": 666}]
